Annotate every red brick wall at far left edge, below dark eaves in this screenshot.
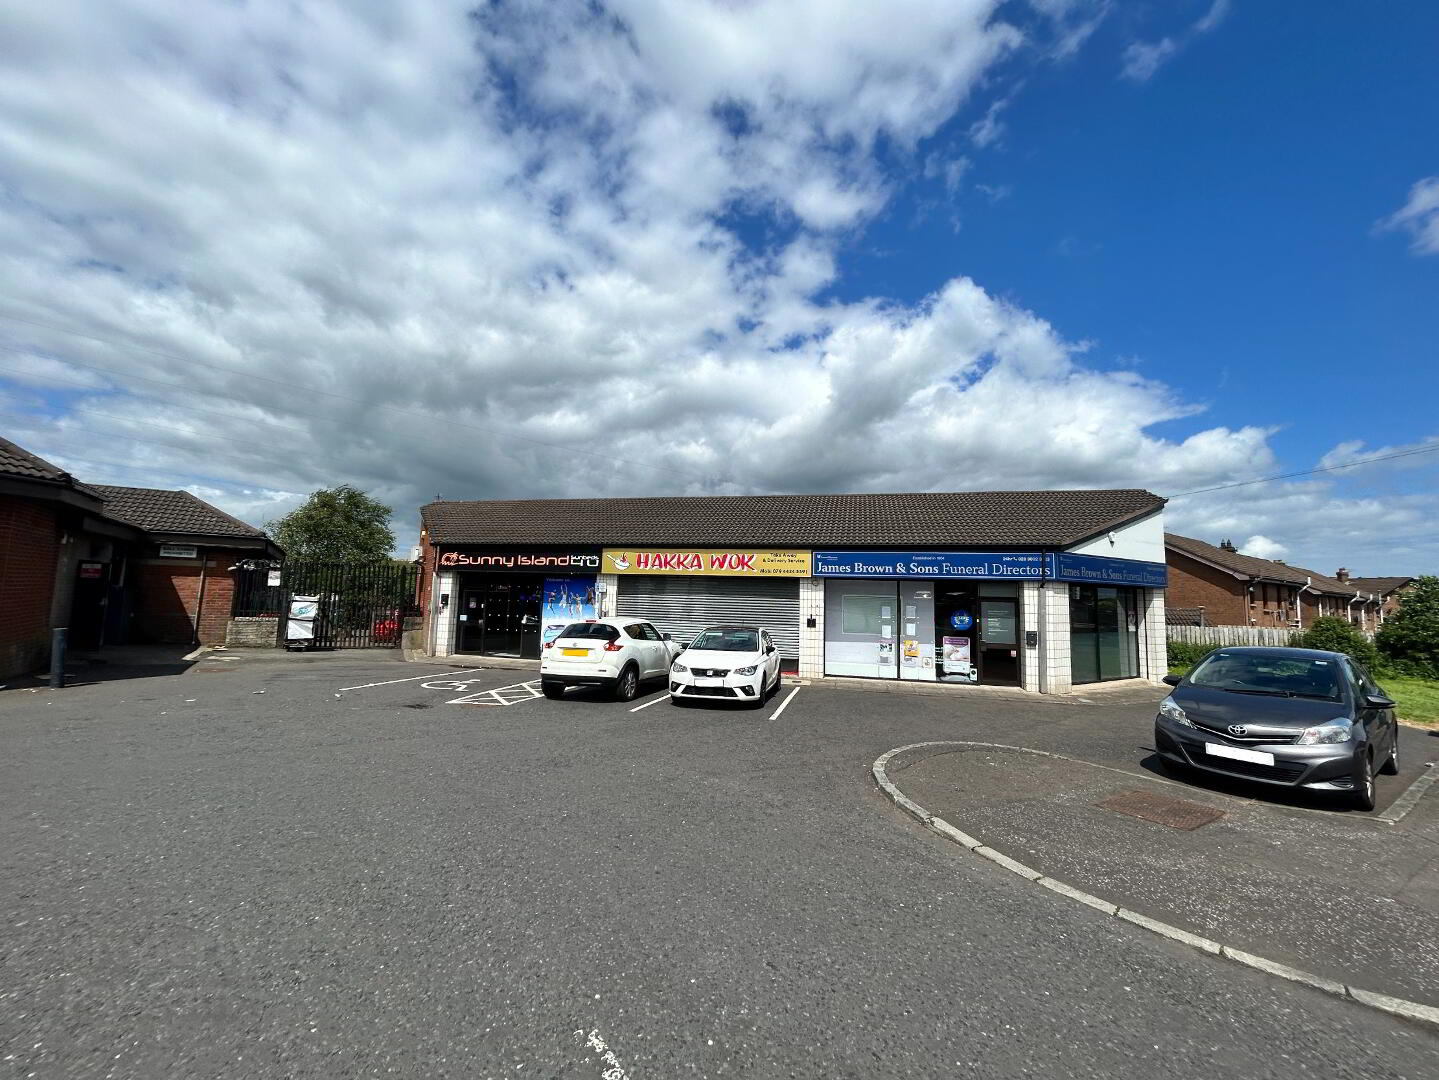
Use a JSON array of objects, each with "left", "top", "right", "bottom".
[{"left": 0, "top": 496, "right": 60, "bottom": 677}]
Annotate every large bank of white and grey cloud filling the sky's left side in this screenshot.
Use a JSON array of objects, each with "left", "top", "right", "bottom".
[{"left": 0, "top": 0, "right": 1419, "bottom": 575}]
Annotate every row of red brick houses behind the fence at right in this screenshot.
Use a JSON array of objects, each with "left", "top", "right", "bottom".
[{"left": 1164, "top": 532, "right": 1381, "bottom": 630}]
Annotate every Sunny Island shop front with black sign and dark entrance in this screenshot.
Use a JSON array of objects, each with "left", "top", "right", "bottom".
[{"left": 436, "top": 548, "right": 600, "bottom": 660}]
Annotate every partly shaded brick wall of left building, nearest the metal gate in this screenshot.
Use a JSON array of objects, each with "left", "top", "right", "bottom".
[{"left": 128, "top": 548, "right": 253, "bottom": 644}]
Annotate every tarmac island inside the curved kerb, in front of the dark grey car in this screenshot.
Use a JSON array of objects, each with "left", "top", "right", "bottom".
[{"left": 889, "top": 745, "right": 1439, "bottom": 1007}]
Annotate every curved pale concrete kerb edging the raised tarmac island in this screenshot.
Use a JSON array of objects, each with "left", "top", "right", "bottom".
[{"left": 871, "top": 739, "right": 1439, "bottom": 1025}]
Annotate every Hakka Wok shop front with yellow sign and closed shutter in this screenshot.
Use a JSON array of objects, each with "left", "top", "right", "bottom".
[{"left": 603, "top": 548, "right": 810, "bottom": 670}]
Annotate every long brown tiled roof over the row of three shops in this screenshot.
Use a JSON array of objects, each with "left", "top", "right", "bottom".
[{"left": 420, "top": 489, "right": 1164, "bottom": 548}]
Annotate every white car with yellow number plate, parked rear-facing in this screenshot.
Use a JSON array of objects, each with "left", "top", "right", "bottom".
[{"left": 540, "top": 618, "right": 679, "bottom": 702}]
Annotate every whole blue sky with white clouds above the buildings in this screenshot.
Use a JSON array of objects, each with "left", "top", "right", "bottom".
[{"left": 0, "top": 0, "right": 1439, "bottom": 575}]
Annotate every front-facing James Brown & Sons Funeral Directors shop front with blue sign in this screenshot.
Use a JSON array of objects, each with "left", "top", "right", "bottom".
[{"left": 813, "top": 551, "right": 1048, "bottom": 686}]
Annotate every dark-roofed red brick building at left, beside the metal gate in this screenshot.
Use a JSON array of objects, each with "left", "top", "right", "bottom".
[{"left": 0, "top": 439, "right": 281, "bottom": 679}]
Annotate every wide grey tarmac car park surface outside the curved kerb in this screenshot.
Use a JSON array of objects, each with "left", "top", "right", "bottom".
[{"left": 0, "top": 654, "right": 1439, "bottom": 1080}]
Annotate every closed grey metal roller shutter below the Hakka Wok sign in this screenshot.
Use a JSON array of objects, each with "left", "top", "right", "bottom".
[{"left": 614, "top": 575, "right": 800, "bottom": 660}]
